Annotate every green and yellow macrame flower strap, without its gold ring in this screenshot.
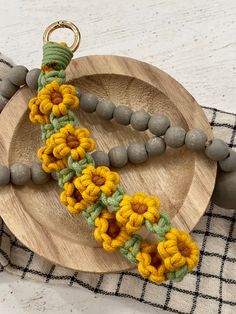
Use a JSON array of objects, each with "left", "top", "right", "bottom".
[{"left": 29, "top": 42, "right": 199, "bottom": 283}]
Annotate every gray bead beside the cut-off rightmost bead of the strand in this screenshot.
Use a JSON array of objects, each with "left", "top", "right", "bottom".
[{"left": 205, "top": 139, "right": 229, "bottom": 161}]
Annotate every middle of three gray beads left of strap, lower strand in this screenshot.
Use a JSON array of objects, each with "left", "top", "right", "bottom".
[{"left": 10, "top": 163, "right": 31, "bottom": 185}]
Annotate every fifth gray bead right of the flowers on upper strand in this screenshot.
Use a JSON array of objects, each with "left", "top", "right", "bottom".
[{"left": 148, "top": 113, "right": 170, "bottom": 136}]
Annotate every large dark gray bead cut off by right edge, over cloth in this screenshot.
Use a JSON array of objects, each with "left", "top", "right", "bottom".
[{"left": 212, "top": 171, "right": 236, "bottom": 209}]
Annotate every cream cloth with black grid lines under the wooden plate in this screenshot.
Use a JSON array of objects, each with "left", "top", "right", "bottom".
[{"left": 0, "top": 54, "right": 236, "bottom": 314}]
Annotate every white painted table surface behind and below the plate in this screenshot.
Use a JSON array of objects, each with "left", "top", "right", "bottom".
[{"left": 0, "top": 0, "right": 236, "bottom": 314}]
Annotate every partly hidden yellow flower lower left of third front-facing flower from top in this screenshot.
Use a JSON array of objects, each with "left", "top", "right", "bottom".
[{"left": 61, "top": 182, "right": 91, "bottom": 214}]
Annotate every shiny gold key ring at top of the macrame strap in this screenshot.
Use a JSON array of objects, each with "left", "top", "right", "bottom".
[{"left": 43, "top": 20, "right": 81, "bottom": 52}]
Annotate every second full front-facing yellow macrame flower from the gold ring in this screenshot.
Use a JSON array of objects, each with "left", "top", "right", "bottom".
[{"left": 49, "top": 124, "right": 95, "bottom": 161}]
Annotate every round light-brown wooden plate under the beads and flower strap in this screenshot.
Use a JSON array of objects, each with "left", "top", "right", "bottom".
[{"left": 0, "top": 56, "right": 216, "bottom": 272}]
